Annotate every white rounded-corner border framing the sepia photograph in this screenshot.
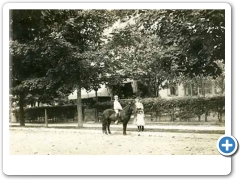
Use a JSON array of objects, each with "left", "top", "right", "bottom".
[{"left": 3, "top": 3, "right": 231, "bottom": 175}]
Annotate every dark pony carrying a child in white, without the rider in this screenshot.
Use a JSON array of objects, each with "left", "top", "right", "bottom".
[{"left": 102, "top": 102, "right": 135, "bottom": 135}]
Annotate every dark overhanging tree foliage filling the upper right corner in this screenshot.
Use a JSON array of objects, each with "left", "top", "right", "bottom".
[{"left": 135, "top": 10, "right": 225, "bottom": 77}]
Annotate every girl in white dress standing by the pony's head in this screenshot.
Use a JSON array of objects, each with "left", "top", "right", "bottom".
[{"left": 135, "top": 98, "right": 145, "bottom": 131}]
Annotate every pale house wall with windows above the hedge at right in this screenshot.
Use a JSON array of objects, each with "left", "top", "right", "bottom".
[{"left": 159, "top": 81, "right": 224, "bottom": 98}]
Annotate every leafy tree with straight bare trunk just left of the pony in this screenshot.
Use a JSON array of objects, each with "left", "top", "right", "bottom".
[{"left": 42, "top": 10, "right": 115, "bottom": 127}]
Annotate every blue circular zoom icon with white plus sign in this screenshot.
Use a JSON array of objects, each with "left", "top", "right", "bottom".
[{"left": 217, "top": 135, "right": 238, "bottom": 156}]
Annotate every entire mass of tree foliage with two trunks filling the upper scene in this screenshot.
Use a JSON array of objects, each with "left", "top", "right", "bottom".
[{"left": 9, "top": 10, "right": 225, "bottom": 126}]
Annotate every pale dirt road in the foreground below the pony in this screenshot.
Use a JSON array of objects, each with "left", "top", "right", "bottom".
[{"left": 9, "top": 128, "right": 221, "bottom": 155}]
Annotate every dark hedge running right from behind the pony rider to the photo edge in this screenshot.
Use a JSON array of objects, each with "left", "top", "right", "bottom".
[{"left": 95, "top": 96, "right": 225, "bottom": 121}]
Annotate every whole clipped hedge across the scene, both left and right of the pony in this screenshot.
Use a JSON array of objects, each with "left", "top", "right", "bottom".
[{"left": 12, "top": 96, "right": 225, "bottom": 122}]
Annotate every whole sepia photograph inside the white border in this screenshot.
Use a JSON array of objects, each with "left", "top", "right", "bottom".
[{"left": 9, "top": 5, "right": 227, "bottom": 156}]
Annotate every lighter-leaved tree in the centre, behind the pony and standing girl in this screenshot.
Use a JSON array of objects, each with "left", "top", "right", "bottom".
[{"left": 109, "top": 25, "right": 179, "bottom": 96}]
